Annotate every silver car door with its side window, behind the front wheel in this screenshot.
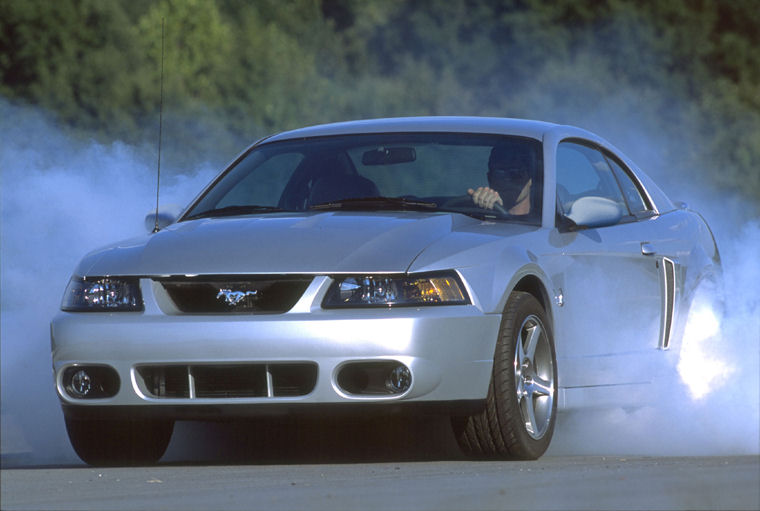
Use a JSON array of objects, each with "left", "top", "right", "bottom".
[{"left": 550, "top": 140, "right": 666, "bottom": 388}]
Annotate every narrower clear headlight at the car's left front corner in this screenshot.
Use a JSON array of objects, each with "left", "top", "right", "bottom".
[{"left": 61, "top": 276, "right": 143, "bottom": 312}]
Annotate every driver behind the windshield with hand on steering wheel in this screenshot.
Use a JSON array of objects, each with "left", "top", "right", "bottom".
[{"left": 467, "top": 143, "right": 535, "bottom": 215}]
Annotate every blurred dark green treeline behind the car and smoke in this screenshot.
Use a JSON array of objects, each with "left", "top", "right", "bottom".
[{"left": 0, "top": 0, "right": 760, "bottom": 208}]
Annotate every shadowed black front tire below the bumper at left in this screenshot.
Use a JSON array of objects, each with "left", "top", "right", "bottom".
[{"left": 66, "top": 418, "right": 174, "bottom": 466}]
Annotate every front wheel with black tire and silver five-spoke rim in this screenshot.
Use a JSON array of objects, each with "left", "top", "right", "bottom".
[{"left": 452, "top": 292, "right": 557, "bottom": 460}]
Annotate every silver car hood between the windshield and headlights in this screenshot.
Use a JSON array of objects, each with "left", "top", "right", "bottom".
[{"left": 77, "top": 212, "right": 534, "bottom": 276}]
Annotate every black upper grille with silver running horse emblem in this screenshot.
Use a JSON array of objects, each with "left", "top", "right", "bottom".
[{"left": 157, "top": 276, "right": 313, "bottom": 314}]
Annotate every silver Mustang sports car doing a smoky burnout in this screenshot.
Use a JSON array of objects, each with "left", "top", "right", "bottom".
[{"left": 51, "top": 117, "right": 720, "bottom": 464}]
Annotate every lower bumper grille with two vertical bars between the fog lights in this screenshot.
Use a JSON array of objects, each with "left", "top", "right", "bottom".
[{"left": 136, "top": 362, "right": 317, "bottom": 399}]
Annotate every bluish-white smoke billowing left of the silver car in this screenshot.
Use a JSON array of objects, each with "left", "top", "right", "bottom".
[{"left": 0, "top": 98, "right": 213, "bottom": 463}]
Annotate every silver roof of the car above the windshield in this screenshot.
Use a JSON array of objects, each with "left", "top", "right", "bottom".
[{"left": 266, "top": 116, "right": 580, "bottom": 142}]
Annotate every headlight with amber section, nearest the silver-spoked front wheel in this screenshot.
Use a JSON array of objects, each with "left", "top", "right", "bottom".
[{"left": 322, "top": 272, "right": 470, "bottom": 309}]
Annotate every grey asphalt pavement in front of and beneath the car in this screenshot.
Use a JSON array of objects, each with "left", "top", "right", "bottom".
[{"left": 0, "top": 456, "right": 760, "bottom": 511}]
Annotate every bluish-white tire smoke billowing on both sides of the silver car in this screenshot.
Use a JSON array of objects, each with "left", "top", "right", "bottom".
[{"left": 0, "top": 98, "right": 760, "bottom": 466}]
